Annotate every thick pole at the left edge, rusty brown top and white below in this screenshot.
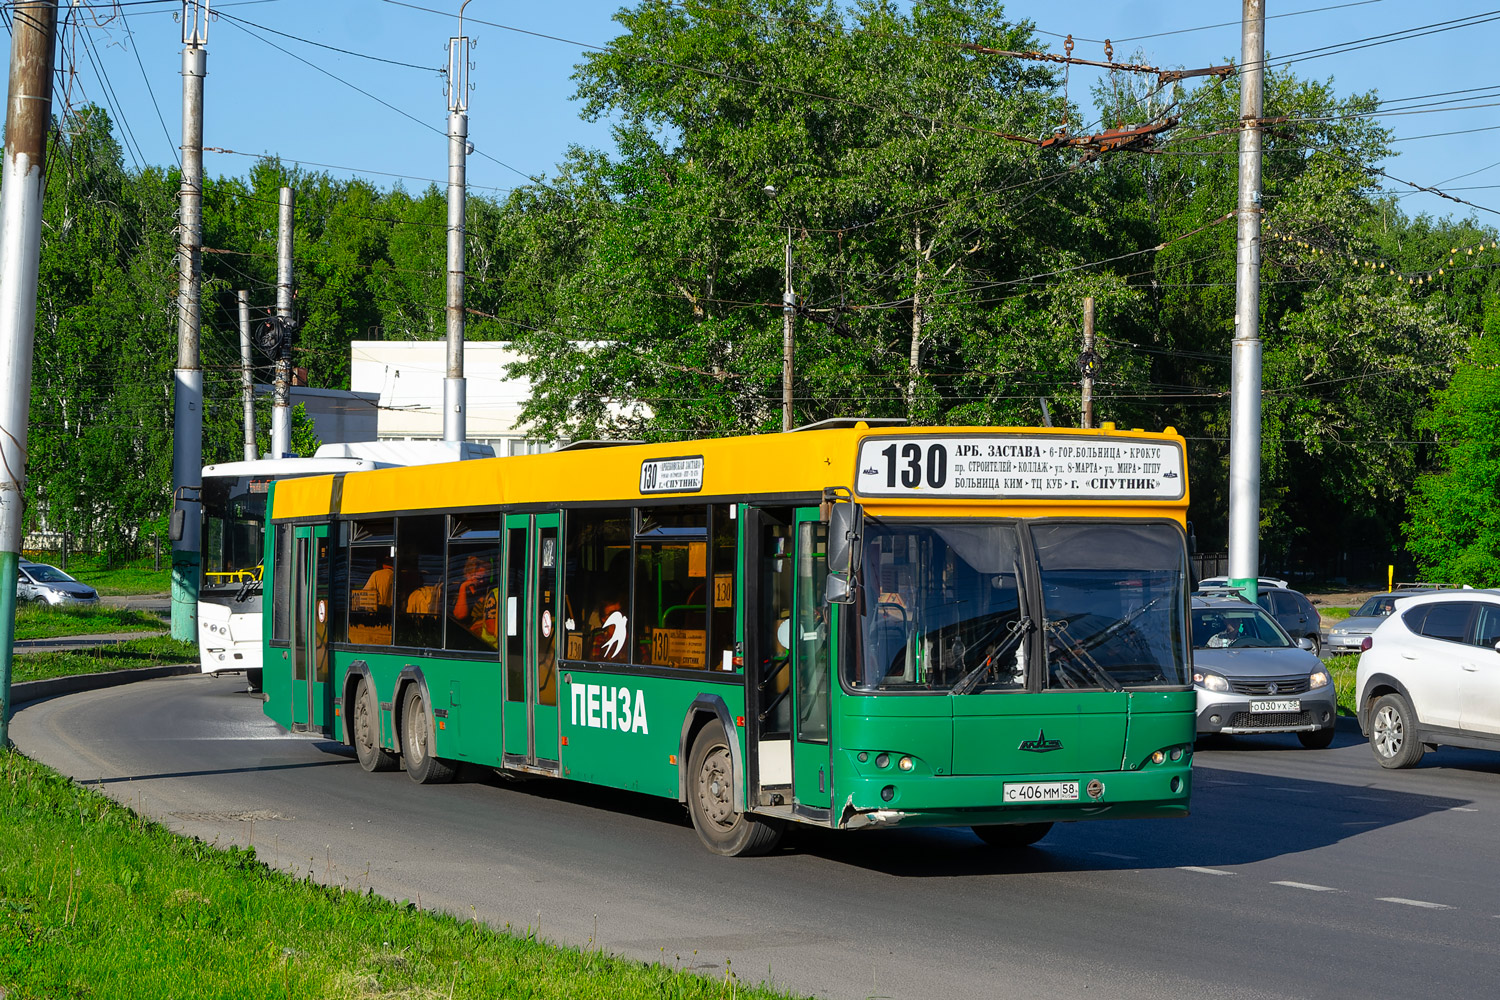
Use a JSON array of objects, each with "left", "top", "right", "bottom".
[{"left": 0, "top": 3, "right": 57, "bottom": 748}]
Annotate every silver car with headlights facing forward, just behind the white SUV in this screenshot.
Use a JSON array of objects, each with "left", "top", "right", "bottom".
[{"left": 1193, "top": 597, "right": 1338, "bottom": 750}]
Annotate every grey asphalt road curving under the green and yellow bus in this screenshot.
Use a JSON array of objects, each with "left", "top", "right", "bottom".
[{"left": 11, "top": 675, "right": 1500, "bottom": 1000}]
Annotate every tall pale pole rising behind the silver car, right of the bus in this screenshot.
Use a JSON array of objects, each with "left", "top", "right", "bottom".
[{"left": 1229, "top": 0, "right": 1266, "bottom": 601}]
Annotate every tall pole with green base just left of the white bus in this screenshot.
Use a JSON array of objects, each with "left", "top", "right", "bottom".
[{"left": 173, "top": 0, "right": 209, "bottom": 640}]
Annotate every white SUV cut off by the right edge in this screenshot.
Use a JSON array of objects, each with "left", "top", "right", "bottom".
[{"left": 1355, "top": 591, "right": 1500, "bottom": 768}]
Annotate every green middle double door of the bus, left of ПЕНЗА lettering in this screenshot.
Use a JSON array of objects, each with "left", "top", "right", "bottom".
[{"left": 503, "top": 514, "right": 561, "bottom": 774}]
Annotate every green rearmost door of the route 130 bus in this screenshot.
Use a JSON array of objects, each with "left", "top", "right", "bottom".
[{"left": 290, "top": 525, "right": 332, "bottom": 732}]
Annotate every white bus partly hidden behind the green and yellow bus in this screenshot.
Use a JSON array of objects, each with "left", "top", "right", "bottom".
[{"left": 198, "top": 441, "right": 495, "bottom": 691}]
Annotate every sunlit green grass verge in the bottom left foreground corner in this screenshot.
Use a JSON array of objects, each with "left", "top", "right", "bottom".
[{"left": 0, "top": 751, "right": 804, "bottom": 1000}]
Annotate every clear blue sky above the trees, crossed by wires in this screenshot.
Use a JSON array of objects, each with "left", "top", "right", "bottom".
[{"left": 11, "top": 0, "right": 1500, "bottom": 225}]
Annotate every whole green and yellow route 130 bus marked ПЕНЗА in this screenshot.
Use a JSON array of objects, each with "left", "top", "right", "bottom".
[{"left": 266, "top": 421, "right": 1196, "bottom": 855}]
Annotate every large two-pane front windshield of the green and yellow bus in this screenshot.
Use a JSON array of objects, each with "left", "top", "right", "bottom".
[{"left": 849, "top": 519, "right": 1188, "bottom": 694}]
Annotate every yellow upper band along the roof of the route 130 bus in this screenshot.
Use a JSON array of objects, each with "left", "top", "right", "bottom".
[{"left": 272, "top": 423, "right": 1188, "bottom": 522}]
